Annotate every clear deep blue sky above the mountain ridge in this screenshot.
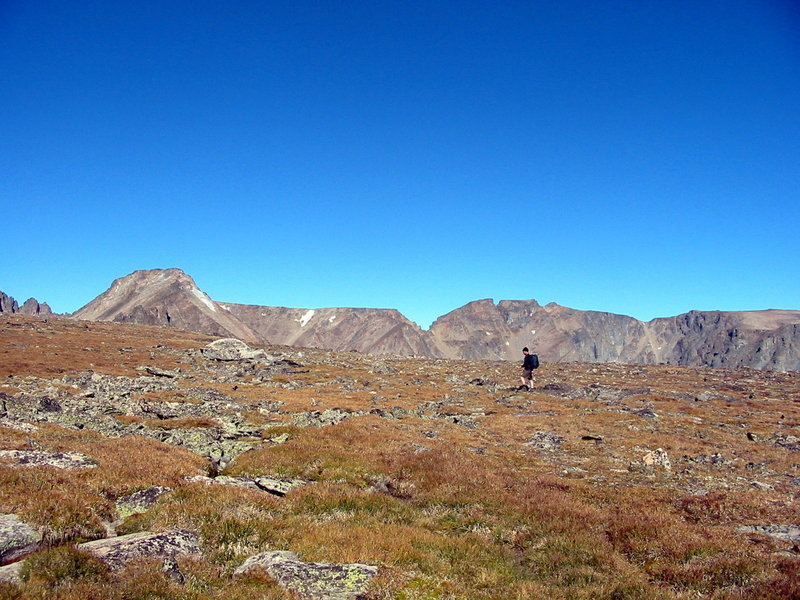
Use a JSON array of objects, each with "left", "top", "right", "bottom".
[{"left": 0, "top": 0, "right": 800, "bottom": 326}]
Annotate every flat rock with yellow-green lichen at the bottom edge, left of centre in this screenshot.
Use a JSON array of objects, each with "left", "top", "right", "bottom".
[{"left": 234, "top": 551, "right": 378, "bottom": 600}]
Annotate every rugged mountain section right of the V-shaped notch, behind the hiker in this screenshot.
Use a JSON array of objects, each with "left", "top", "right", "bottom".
[{"left": 430, "top": 300, "right": 800, "bottom": 370}]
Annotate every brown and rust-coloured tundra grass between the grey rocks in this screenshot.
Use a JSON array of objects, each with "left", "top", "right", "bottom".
[{"left": 0, "top": 318, "right": 800, "bottom": 600}]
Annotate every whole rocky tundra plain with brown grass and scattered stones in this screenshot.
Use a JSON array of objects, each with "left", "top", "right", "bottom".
[{"left": 0, "top": 315, "right": 800, "bottom": 599}]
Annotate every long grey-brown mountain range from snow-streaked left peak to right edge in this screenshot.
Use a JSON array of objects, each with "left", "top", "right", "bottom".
[{"left": 59, "top": 269, "right": 800, "bottom": 370}]
